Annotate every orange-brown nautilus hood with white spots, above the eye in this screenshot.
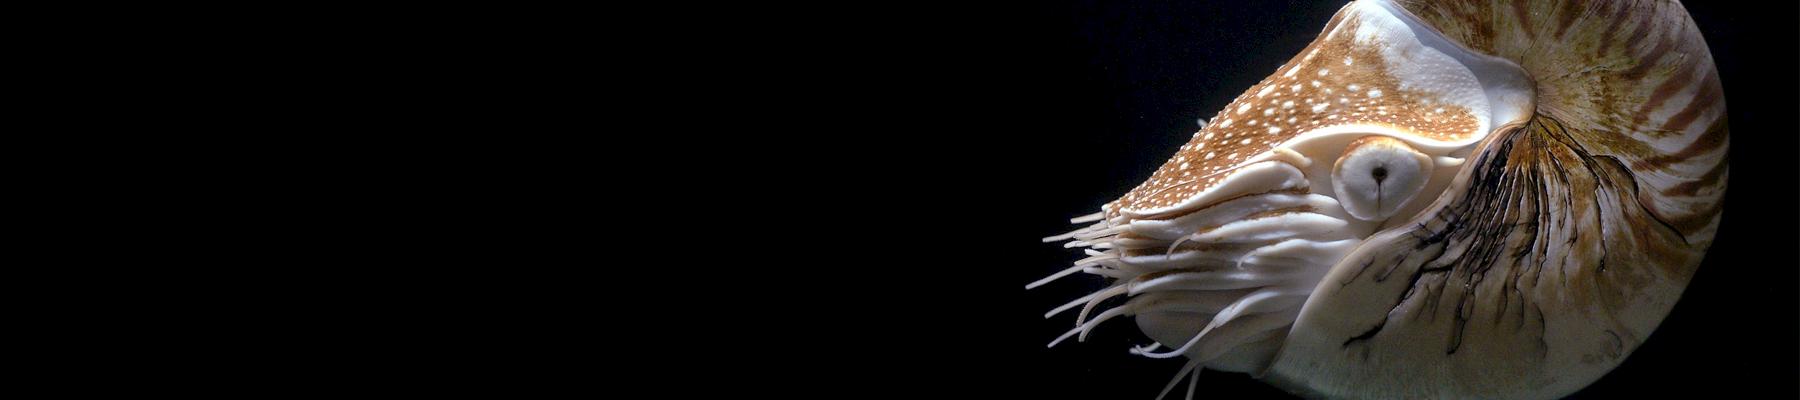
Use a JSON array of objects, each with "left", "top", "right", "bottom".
[{"left": 1107, "top": 2, "right": 1532, "bottom": 218}]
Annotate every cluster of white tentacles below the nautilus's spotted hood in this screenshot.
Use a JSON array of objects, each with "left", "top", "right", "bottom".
[{"left": 1026, "top": 160, "right": 1366, "bottom": 398}]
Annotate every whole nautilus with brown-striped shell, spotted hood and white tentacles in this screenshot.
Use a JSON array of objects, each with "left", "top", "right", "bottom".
[{"left": 1028, "top": 0, "right": 1728, "bottom": 398}]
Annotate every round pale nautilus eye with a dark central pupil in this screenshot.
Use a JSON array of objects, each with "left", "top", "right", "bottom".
[{"left": 1332, "top": 137, "right": 1431, "bottom": 220}]
